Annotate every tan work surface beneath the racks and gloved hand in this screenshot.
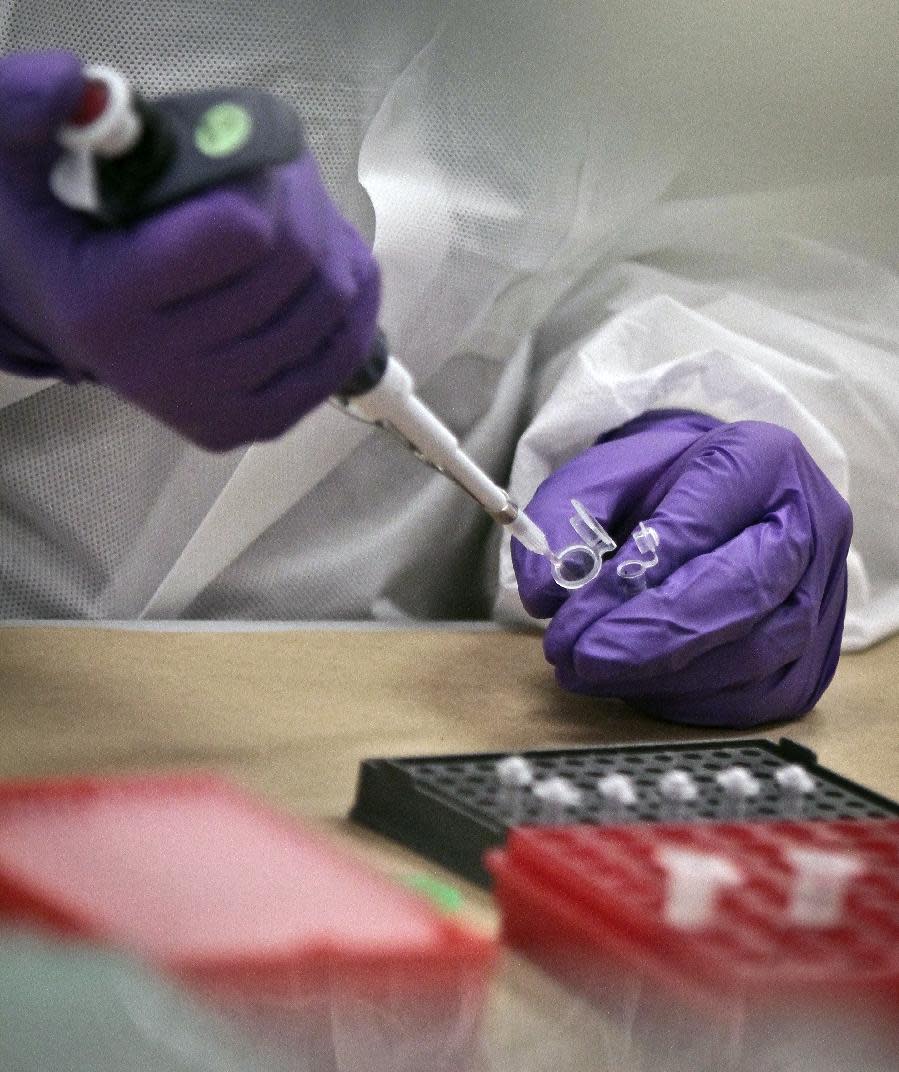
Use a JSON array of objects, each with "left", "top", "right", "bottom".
[{"left": 0, "top": 627, "right": 899, "bottom": 1072}]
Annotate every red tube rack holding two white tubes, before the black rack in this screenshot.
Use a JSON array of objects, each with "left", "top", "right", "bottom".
[{"left": 488, "top": 820, "right": 899, "bottom": 1070}]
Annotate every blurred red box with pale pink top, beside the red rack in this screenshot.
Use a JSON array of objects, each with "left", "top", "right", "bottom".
[{"left": 0, "top": 775, "right": 495, "bottom": 1069}]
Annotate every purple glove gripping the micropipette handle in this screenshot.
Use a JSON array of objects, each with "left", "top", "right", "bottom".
[{"left": 0, "top": 53, "right": 379, "bottom": 450}]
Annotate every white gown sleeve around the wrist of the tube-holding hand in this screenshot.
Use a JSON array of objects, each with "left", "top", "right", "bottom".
[{"left": 496, "top": 292, "right": 899, "bottom": 650}]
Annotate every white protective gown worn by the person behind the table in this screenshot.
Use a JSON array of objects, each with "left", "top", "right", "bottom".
[{"left": 0, "top": 0, "right": 899, "bottom": 647}]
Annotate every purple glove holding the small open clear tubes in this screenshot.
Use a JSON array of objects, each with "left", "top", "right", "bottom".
[{"left": 512, "top": 412, "right": 852, "bottom": 726}]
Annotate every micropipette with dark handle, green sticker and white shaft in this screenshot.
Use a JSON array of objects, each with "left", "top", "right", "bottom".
[{"left": 50, "top": 66, "right": 614, "bottom": 589}]
